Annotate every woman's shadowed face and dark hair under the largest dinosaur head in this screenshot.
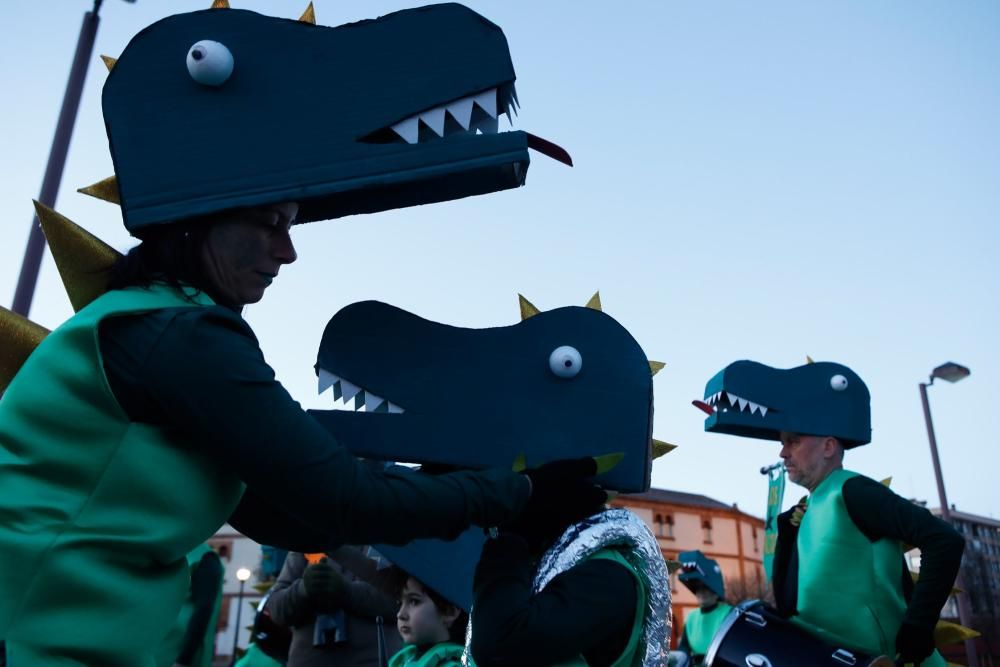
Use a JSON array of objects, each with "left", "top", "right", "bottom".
[{"left": 201, "top": 202, "right": 299, "bottom": 306}]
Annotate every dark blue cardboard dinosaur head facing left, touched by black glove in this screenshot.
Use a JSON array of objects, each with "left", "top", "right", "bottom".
[{"left": 313, "top": 295, "right": 669, "bottom": 492}]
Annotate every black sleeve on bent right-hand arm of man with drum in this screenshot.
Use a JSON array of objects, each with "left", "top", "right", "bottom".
[{"left": 843, "top": 476, "right": 965, "bottom": 631}]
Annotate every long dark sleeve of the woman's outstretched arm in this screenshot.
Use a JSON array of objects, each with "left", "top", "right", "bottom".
[{"left": 99, "top": 307, "right": 529, "bottom": 550}]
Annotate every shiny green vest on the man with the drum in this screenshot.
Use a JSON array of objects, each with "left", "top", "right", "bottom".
[{"left": 793, "top": 470, "right": 945, "bottom": 667}]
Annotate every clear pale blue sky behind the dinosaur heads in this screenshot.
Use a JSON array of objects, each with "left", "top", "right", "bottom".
[{"left": 0, "top": 0, "right": 1000, "bottom": 517}]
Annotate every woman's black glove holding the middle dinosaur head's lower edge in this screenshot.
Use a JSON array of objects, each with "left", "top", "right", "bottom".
[{"left": 500, "top": 457, "right": 608, "bottom": 551}]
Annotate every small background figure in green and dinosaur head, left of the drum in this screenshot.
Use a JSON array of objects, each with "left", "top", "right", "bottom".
[{"left": 678, "top": 551, "right": 732, "bottom": 665}]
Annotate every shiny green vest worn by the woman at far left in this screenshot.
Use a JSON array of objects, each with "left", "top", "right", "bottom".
[{"left": 0, "top": 286, "right": 243, "bottom": 667}]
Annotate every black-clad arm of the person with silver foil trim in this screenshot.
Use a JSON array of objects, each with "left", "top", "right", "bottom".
[{"left": 472, "top": 535, "right": 637, "bottom": 667}]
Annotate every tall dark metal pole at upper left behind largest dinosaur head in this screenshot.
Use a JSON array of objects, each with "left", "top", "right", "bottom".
[{"left": 11, "top": 0, "right": 101, "bottom": 317}]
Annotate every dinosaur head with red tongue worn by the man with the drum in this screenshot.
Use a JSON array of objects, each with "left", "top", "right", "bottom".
[{"left": 697, "top": 361, "right": 871, "bottom": 449}]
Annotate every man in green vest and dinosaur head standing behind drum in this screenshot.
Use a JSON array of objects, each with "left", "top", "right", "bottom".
[{"left": 696, "top": 361, "right": 965, "bottom": 667}]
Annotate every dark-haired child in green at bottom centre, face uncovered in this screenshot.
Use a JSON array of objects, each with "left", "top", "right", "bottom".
[{"left": 389, "top": 576, "right": 468, "bottom": 667}]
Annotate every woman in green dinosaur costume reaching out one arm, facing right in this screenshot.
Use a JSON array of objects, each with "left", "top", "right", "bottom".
[{"left": 0, "top": 6, "right": 591, "bottom": 667}]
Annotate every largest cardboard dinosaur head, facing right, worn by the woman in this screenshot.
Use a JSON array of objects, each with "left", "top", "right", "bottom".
[{"left": 103, "top": 0, "right": 569, "bottom": 235}]
